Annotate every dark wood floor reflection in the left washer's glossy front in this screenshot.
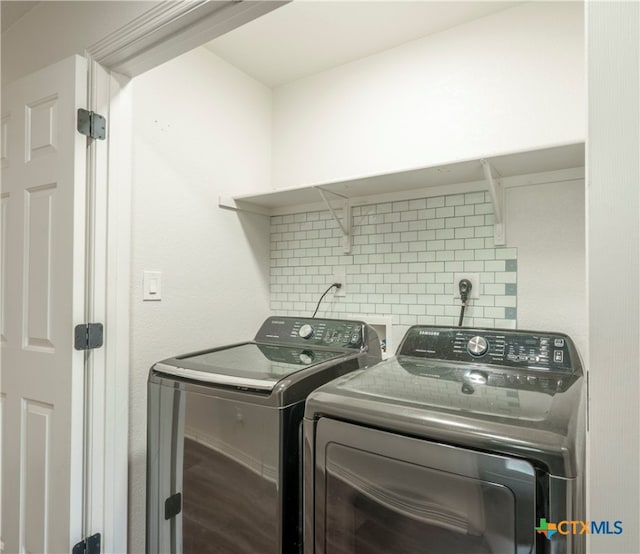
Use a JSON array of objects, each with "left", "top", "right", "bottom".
[{"left": 182, "top": 439, "right": 277, "bottom": 554}]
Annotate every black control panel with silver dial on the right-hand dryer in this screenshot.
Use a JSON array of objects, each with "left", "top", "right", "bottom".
[{"left": 399, "top": 326, "right": 581, "bottom": 372}]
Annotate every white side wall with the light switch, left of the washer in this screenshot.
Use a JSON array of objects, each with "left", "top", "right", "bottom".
[{"left": 129, "top": 49, "right": 271, "bottom": 553}]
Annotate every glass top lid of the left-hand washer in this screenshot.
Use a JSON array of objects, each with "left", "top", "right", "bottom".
[{"left": 153, "top": 343, "right": 345, "bottom": 392}]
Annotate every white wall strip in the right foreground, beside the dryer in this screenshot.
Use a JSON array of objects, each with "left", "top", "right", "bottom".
[{"left": 587, "top": 2, "right": 640, "bottom": 554}]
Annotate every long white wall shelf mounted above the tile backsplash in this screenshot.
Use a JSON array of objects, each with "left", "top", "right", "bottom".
[{"left": 219, "top": 142, "right": 585, "bottom": 217}]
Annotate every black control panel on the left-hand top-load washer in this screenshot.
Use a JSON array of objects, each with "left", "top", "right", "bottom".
[{"left": 255, "top": 317, "right": 366, "bottom": 349}]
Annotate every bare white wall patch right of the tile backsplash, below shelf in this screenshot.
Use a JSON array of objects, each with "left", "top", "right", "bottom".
[{"left": 505, "top": 180, "right": 588, "bottom": 354}]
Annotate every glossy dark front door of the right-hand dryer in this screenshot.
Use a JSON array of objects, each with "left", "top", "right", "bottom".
[{"left": 307, "top": 418, "right": 535, "bottom": 554}]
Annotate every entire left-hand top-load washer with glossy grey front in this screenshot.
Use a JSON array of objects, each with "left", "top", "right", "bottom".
[{"left": 146, "top": 317, "right": 381, "bottom": 554}]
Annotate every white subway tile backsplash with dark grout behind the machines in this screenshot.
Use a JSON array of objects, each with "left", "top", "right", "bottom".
[{"left": 270, "top": 191, "right": 517, "bottom": 328}]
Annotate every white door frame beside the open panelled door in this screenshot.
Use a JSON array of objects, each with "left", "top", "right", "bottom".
[{"left": 84, "top": 0, "right": 290, "bottom": 552}]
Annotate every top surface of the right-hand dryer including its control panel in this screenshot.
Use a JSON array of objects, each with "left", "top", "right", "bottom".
[{"left": 305, "top": 326, "right": 585, "bottom": 477}]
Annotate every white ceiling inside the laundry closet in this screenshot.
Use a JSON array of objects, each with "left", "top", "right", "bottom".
[{"left": 206, "top": 0, "right": 521, "bottom": 87}]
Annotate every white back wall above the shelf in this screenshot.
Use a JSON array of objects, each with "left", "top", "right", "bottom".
[{"left": 273, "top": 2, "right": 586, "bottom": 188}]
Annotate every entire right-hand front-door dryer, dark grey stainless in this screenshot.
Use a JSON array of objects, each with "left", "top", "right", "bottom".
[{"left": 304, "top": 326, "right": 586, "bottom": 554}]
